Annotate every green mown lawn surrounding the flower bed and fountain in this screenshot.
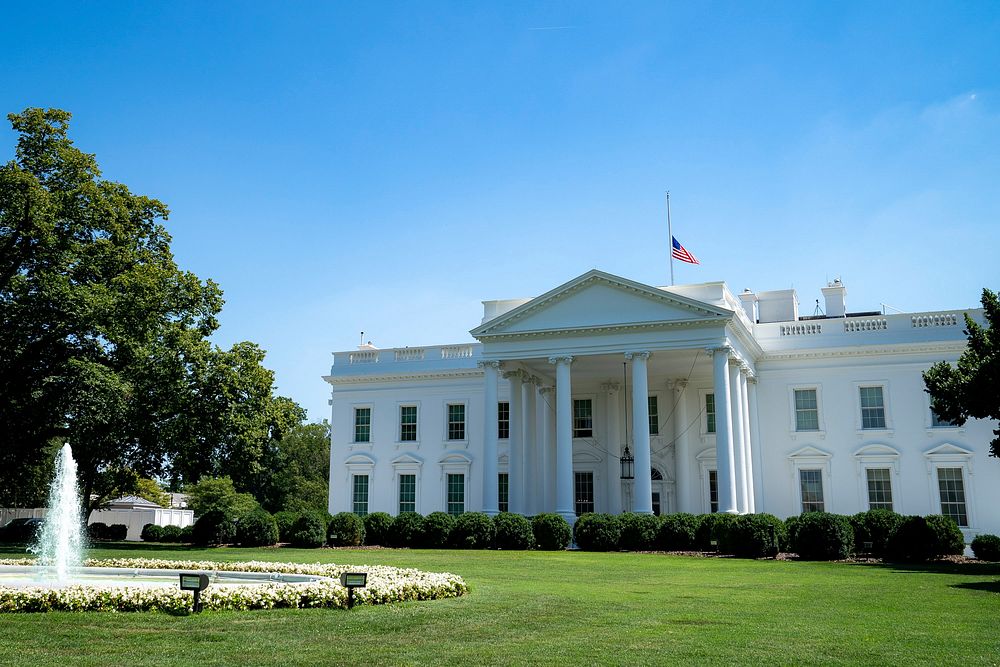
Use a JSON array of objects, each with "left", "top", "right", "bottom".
[{"left": 0, "top": 545, "right": 1000, "bottom": 667}]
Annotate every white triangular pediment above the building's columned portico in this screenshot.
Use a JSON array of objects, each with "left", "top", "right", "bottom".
[{"left": 470, "top": 269, "right": 733, "bottom": 338}]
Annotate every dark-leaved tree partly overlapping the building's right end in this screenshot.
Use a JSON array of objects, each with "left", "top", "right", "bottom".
[{"left": 924, "top": 289, "right": 1000, "bottom": 457}]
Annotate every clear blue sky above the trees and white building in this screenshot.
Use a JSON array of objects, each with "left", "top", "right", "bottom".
[{"left": 0, "top": 1, "right": 1000, "bottom": 420}]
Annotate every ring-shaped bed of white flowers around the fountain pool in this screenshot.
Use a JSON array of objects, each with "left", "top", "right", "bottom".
[{"left": 0, "top": 558, "right": 468, "bottom": 613}]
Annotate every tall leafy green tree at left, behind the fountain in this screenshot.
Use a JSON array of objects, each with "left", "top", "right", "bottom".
[{"left": 0, "top": 109, "right": 302, "bottom": 506}]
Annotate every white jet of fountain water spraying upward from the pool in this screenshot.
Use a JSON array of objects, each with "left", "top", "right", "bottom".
[{"left": 32, "top": 443, "right": 83, "bottom": 582}]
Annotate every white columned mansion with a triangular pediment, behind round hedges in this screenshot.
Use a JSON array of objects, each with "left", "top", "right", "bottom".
[{"left": 324, "top": 270, "right": 1000, "bottom": 539}]
